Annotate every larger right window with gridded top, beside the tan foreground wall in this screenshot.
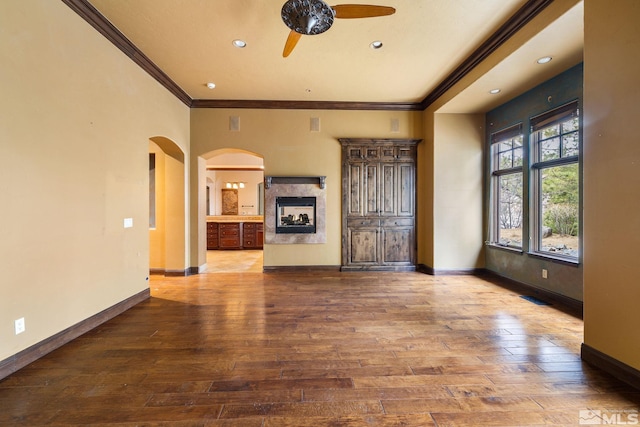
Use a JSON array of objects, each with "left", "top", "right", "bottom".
[{"left": 531, "top": 102, "right": 580, "bottom": 260}]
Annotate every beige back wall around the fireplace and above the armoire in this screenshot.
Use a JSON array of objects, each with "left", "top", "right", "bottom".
[{"left": 191, "top": 109, "right": 422, "bottom": 267}]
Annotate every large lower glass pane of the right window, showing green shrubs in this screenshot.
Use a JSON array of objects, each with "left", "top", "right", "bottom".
[{"left": 539, "top": 163, "right": 579, "bottom": 257}]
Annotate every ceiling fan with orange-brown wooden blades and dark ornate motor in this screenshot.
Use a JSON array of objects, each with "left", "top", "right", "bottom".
[{"left": 281, "top": 0, "right": 396, "bottom": 58}]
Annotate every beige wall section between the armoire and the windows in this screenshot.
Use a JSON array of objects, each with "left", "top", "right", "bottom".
[{"left": 418, "top": 109, "right": 484, "bottom": 272}]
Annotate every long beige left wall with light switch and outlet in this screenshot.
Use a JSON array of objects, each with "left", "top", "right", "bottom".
[{"left": 0, "top": 0, "right": 189, "bottom": 360}]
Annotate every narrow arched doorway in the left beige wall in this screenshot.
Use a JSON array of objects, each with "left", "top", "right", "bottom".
[{"left": 149, "top": 136, "right": 187, "bottom": 276}]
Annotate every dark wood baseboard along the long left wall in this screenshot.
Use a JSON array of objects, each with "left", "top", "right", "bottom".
[{"left": 0, "top": 289, "right": 151, "bottom": 380}]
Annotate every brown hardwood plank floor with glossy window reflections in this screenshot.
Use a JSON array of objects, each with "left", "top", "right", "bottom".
[{"left": 0, "top": 271, "right": 640, "bottom": 427}]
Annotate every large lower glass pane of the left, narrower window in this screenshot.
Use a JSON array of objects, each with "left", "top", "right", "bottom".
[{"left": 497, "top": 173, "right": 522, "bottom": 248}]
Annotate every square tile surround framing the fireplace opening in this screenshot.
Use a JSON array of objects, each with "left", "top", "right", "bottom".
[{"left": 264, "top": 176, "right": 327, "bottom": 244}]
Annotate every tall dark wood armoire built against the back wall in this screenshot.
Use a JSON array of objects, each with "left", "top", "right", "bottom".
[{"left": 339, "top": 138, "right": 421, "bottom": 271}]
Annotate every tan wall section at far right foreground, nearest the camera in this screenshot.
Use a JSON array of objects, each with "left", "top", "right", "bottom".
[{"left": 584, "top": 0, "right": 640, "bottom": 369}]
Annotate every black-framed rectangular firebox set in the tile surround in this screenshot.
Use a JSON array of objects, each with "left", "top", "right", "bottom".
[{"left": 276, "top": 197, "right": 316, "bottom": 234}]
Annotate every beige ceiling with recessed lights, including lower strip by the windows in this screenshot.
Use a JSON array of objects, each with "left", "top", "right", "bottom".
[{"left": 89, "top": 0, "right": 583, "bottom": 112}]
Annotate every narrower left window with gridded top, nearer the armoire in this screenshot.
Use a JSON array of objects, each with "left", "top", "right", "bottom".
[{"left": 491, "top": 125, "right": 524, "bottom": 248}]
